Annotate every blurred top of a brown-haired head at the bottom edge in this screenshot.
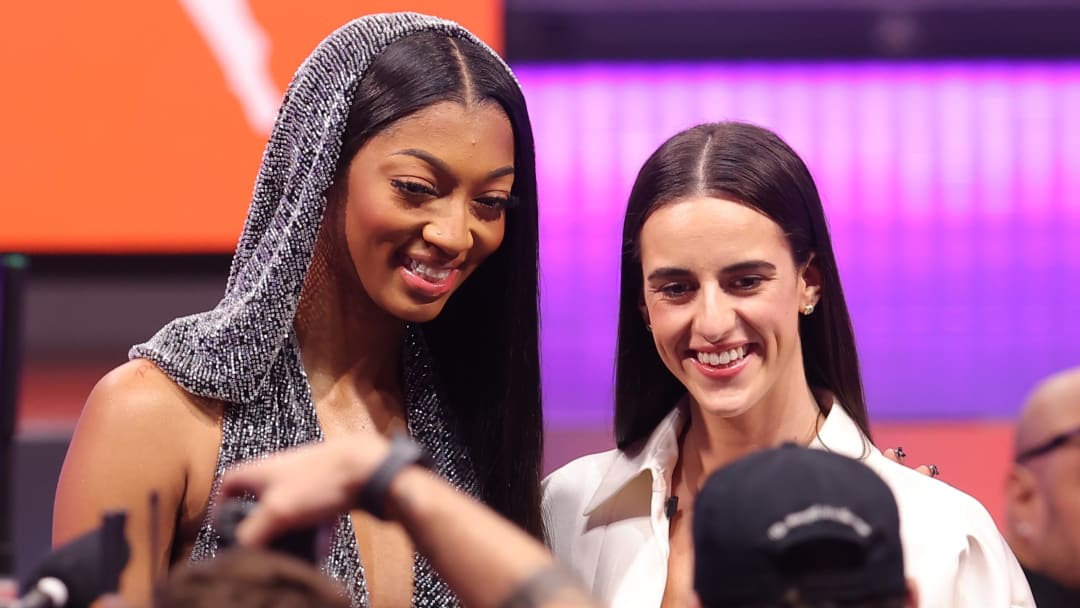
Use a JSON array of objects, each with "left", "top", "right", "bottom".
[{"left": 153, "top": 549, "right": 349, "bottom": 608}]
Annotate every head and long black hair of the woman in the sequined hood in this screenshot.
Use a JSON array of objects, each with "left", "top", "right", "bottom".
[{"left": 315, "top": 31, "right": 542, "bottom": 535}]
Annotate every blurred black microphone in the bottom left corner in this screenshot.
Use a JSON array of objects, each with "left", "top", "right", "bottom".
[{"left": 14, "top": 513, "right": 131, "bottom": 608}]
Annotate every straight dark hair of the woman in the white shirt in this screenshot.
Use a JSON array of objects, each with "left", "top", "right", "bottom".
[{"left": 615, "top": 122, "right": 869, "bottom": 449}]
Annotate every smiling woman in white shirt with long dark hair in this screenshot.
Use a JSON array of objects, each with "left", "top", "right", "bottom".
[{"left": 543, "top": 123, "right": 1034, "bottom": 608}]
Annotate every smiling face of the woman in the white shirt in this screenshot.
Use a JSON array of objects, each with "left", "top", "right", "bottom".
[{"left": 640, "top": 197, "right": 820, "bottom": 417}]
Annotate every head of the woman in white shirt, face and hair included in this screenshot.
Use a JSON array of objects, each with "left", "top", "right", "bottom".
[{"left": 616, "top": 122, "right": 868, "bottom": 447}]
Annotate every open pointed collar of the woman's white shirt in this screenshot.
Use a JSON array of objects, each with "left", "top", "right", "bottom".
[{"left": 583, "top": 395, "right": 877, "bottom": 516}]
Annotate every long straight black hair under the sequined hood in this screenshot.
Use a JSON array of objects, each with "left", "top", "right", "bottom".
[{"left": 335, "top": 32, "right": 543, "bottom": 538}]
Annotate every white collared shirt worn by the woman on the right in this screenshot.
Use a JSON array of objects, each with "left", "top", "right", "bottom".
[{"left": 543, "top": 404, "right": 1035, "bottom": 608}]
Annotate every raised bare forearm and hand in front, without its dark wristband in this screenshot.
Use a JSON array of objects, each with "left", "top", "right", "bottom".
[{"left": 222, "top": 436, "right": 596, "bottom": 608}]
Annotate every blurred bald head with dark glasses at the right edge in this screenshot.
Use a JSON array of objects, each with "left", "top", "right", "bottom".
[{"left": 1005, "top": 368, "right": 1080, "bottom": 590}]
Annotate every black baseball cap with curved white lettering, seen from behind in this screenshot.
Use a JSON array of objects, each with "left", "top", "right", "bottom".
[{"left": 693, "top": 444, "right": 907, "bottom": 608}]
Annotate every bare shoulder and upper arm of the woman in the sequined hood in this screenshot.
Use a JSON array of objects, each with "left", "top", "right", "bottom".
[{"left": 53, "top": 361, "right": 214, "bottom": 604}]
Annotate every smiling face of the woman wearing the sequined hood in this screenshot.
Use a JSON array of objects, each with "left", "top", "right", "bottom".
[{"left": 342, "top": 102, "right": 514, "bottom": 322}]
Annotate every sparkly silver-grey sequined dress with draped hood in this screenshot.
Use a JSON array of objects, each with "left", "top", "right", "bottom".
[{"left": 130, "top": 13, "right": 518, "bottom": 606}]
